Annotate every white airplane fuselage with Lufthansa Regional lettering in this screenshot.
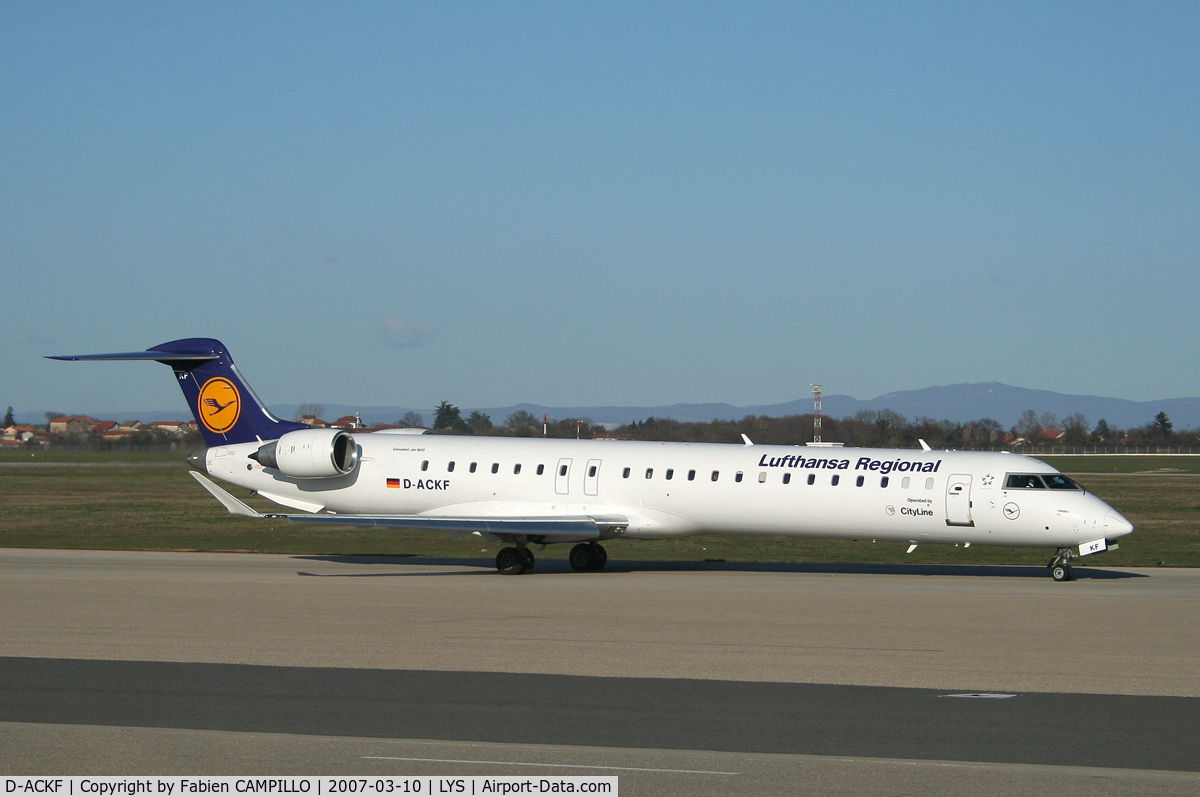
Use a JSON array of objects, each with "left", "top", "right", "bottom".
[{"left": 205, "top": 433, "right": 1133, "bottom": 547}]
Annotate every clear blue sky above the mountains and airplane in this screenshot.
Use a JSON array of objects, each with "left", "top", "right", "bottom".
[{"left": 0, "top": 2, "right": 1200, "bottom": 413}]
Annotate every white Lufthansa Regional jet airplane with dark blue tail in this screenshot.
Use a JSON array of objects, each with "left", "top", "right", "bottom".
[{"left": 49, "top": 337, "right": 1133, "bottom": 581}]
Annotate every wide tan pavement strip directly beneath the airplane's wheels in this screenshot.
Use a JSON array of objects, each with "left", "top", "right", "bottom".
[{"left": 0, "top": 552, "right": 1200, "bottom": 697}]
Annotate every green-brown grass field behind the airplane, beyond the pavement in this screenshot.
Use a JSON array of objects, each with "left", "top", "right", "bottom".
[{"left": 0, "top": 451, "right": 1200, "bottom": 567}]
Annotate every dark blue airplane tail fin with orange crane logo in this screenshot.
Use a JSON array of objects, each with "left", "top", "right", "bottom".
[{"left": 49, "top": 337, "right": 308, "bottom": 448}]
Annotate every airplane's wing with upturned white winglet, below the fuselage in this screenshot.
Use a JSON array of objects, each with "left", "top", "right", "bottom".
[{"left": 191, "top": 471, "right": 629, "bottom": 543}]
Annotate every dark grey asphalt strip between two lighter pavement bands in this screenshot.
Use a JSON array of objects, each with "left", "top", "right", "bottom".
[{"left": 0, "top": 658, "right": 1200, "bottom": 771}]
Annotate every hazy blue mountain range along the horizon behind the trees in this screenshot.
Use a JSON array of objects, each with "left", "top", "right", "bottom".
[{"left": 17, "top": 382, "right": 1200, "bottom": 430}]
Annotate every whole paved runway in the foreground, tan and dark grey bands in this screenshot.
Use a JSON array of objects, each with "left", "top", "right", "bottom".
[{"left": 0, "top": 550, "right": 1200, "bottom": 795}]
